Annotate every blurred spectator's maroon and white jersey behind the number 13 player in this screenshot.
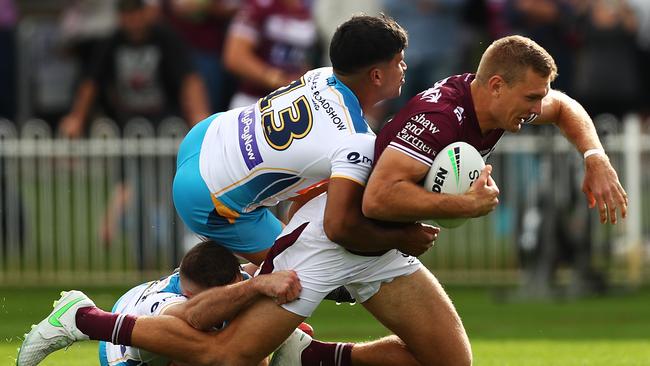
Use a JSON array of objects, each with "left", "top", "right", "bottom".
[{"left": 230, "top": 0, "right": 317, "bottom": 96}]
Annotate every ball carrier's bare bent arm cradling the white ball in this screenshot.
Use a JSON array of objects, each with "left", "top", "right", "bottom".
[{"left": 363, "top": 149, "right": 499, "bottom": 222}]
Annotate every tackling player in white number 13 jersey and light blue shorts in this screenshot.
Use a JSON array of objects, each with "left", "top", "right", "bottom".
[{"left": 173, "top": 16, "right": 432, "bottom": 265}]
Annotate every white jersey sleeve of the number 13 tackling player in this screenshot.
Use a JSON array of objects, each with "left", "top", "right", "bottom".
[{"left": 330, "top": 134, "right": 375, "bottom": 186}]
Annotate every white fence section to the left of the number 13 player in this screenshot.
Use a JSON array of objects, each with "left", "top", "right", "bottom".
[{"left": 0, "top": 119, "right": 187, "bottom": 283}]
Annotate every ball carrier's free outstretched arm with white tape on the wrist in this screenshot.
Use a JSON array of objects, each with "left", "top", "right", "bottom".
[{"left": 536, "top": 90, "right": 628, "bottom": 224}]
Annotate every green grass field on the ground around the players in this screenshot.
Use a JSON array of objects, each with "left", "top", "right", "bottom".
[{"left": 0, "top": 287, "right": 650, "bottom": 366}]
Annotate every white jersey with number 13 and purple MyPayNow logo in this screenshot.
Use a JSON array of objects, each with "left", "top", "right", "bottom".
[{"left": 199, "top": 67, "right": 375, "bottom": 212}]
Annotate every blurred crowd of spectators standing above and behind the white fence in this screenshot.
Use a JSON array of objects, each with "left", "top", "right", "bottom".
[{"left": 0, "top": 0, "right": 650, "bottom": 129}]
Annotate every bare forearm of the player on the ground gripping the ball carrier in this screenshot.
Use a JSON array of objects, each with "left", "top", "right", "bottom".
[{"left": 165, "top": 271, "right": 302, "bottom": 330}]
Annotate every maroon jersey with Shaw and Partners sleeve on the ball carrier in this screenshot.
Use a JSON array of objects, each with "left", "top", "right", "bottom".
[{"left": 374, "top": 74, "right": 504, "bottom": 166}]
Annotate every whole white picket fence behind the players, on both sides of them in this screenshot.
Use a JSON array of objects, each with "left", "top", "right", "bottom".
[{"left": 0, "top": 116, "right": 650, "bottom": 284}]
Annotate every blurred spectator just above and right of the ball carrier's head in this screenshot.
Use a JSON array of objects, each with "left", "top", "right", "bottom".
[{"left": 506, "top": 0, "right": 575, "bottom": 93}]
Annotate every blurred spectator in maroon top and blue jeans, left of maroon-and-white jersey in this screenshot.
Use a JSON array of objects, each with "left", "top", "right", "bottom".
[{"left": 161, "top": 0, "right": 240, "bottom": 111}]
